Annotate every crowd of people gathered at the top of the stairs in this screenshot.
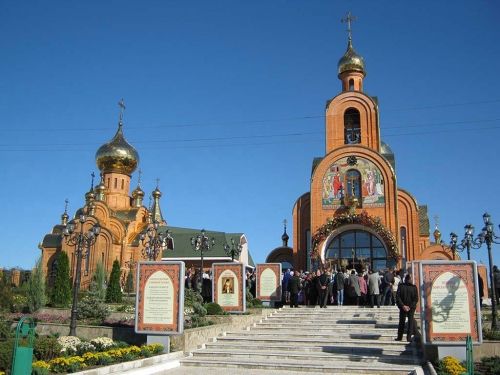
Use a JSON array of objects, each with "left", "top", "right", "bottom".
[{"left": 281, "top": 268, "right": 403, "bottom": 308}]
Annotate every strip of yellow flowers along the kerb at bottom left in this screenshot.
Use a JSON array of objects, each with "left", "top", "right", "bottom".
[{"left": 33, "top": 344, "right": 163, "bottom": 375}]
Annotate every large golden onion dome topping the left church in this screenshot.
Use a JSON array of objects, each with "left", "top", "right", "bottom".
[{"left": 95, "top": 122, "right": 139, "bottom": 176}]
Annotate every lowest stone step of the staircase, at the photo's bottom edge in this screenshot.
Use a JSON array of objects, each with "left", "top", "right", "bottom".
[{"left": 181, "top": 357, "right": 420, "bottom": 375}]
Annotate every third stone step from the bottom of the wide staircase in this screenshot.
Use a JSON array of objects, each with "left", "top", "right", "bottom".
[{"left": 205, "top": 340, "right": 418, "bottom": 356}]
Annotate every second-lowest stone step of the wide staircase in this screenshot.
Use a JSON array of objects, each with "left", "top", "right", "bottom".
[{"left": 192, "top": 347, "right": 420, "bottom": 365}]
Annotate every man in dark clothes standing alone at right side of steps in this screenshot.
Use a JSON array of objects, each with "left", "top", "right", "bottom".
[{"left": 396, "top": 274, "right": 418, "bottom": 342}]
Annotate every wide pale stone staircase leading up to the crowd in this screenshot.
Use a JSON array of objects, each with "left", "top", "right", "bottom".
[{"left": 180, "top": 306, "right": 424, "bottom": 374}]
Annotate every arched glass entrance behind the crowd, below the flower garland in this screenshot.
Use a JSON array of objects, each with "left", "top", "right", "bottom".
[{"left": 325, "top": 229, "right": 394, "bottom": 272}]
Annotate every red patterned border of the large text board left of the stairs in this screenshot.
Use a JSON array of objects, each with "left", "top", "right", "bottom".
[{"left": 135, "top": 263, "right": 182, "bottom": 332}]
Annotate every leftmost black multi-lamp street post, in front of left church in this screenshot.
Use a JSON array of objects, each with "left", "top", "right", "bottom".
[{"left": 63, "top": 215, "right": 101, "bottom": 336}]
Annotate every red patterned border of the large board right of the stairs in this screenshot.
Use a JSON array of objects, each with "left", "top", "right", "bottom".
[{"left": 421, "top": 263, "right": 480, "bottom": 343}]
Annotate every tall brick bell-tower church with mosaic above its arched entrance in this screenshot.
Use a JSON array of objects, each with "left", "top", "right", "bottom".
[{"left": 267, "top": 24, "right": 451, "bottom": 270}]
